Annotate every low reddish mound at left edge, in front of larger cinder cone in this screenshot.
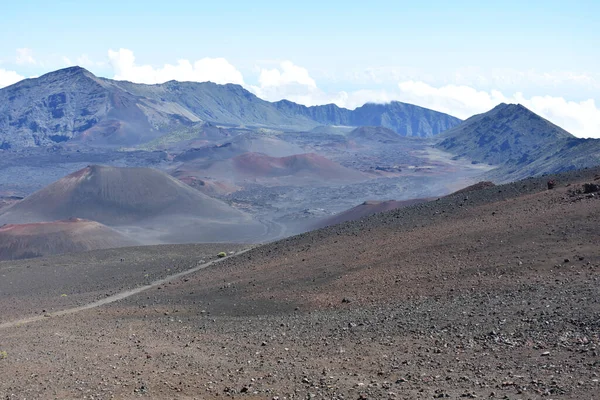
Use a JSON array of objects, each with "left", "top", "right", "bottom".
[{"left": 0, "top": 219, "right": 139, "bottom": 260}]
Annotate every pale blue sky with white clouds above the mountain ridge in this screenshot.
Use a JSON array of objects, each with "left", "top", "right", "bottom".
[{"left": 0, "top": 0, "right": 600, "bottom": 137}]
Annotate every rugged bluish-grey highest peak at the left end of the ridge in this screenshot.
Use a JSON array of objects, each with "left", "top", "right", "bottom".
[{"left": 0, "top": 67, "right": 188, "bottom": 149}]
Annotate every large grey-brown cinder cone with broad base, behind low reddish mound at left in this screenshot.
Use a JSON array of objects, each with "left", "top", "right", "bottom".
[{"left": 0, "top": 165, "right": 262, "bottom": 242}]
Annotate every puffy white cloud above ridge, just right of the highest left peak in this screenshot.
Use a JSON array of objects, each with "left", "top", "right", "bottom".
[{"left": 108, "top": 49, "right": 244, "bottom": 85}]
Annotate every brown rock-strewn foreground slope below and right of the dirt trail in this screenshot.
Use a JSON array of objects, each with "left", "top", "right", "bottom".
[{"left": 0, "top": 170, "right": 600, "bottom": 400}]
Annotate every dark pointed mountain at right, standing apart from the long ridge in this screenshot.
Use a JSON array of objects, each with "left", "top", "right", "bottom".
[{"left": 436, "top": 104, "right": 600, "bottom": 182}]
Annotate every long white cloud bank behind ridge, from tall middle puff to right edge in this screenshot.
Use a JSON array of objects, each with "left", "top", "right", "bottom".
[{"left": 249, "top": 61, "right": 600, "bottom": 138}]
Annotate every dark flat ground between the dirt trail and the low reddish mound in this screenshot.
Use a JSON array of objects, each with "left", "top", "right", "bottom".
[{"left": 0, "top": 244, "right": 245, "bottom": 324}]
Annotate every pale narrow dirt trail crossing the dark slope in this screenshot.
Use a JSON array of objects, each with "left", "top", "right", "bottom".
[{"left": 0, "top": 248, "right": 252, "bottom": 329}]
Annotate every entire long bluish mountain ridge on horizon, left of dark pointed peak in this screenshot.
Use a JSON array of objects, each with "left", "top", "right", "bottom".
[{"left": 0, "top": 67, "right": 460, "bottom": 149}]
